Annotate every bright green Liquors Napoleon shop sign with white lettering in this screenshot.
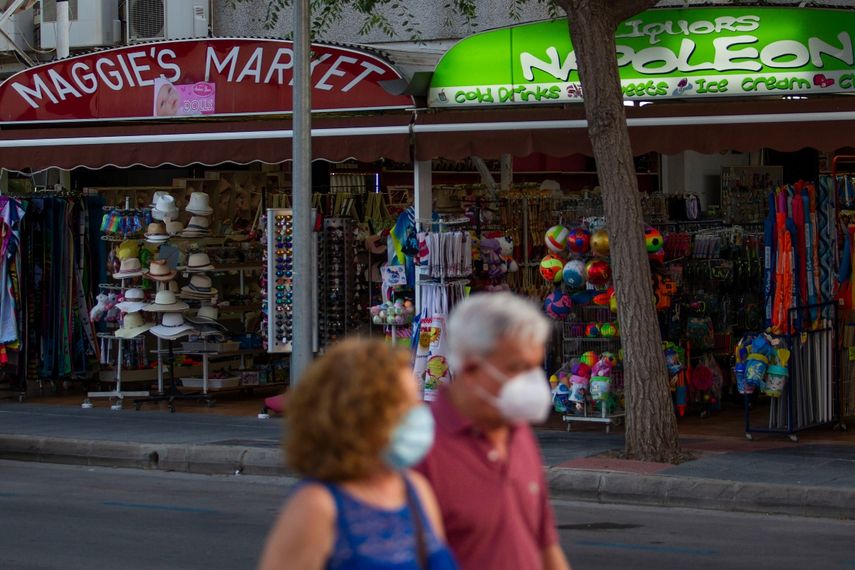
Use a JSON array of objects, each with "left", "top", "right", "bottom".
[{"left": 428, "top": 8, "right": 855, "bottom": 107}]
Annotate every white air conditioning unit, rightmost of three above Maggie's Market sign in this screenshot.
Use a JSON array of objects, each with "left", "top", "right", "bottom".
[{"left": 125, "top": 0, "right": 211, "bottom": 43}]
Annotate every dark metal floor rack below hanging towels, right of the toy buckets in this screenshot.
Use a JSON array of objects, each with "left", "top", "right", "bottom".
[{"left": 744, "top": 301, "right": 846, "bottom": 442}]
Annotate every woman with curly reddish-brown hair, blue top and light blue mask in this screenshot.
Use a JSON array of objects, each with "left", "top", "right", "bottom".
[{"left": 259, "top": 339, "right": 457, "bottom": 570}]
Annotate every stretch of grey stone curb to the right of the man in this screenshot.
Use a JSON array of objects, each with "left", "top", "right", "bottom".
[{"left": 546, "top": 467, "right": 855, "bottom": 519}]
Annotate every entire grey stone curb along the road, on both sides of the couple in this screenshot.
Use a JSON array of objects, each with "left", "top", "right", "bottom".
[{"left": 0, "top": 435, "right": 855, "bottom": 519}]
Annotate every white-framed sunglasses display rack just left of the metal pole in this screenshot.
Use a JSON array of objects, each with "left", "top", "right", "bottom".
[{"left": 262, "top": 208, "right": 294, "bottom": 353}]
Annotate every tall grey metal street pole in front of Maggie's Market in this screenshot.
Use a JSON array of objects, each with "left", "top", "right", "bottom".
[{"left": 291, "top": 0, "right": 313, "bottom": 386}]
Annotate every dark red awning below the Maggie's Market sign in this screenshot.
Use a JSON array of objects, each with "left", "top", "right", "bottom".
[{"left": 0, "top": 113, "right": 411, "bottom": 171}]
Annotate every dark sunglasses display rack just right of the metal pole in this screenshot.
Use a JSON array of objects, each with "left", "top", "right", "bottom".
[{"left": 318, "top": 218, "right": 362, "bottom": 347}]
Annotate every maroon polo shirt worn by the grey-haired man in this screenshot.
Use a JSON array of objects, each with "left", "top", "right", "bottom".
[{"left": 416, "top": 390, "right": 558, "bottom": 570}]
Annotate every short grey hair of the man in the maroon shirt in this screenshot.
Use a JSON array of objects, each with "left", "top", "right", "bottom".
[{"left": 448, "top": 293, "right": 552, "bottom": 370}]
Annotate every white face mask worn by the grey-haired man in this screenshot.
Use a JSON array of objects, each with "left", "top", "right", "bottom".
[{"left": 481, "top": 361, "right": 552, "bottom": 424}]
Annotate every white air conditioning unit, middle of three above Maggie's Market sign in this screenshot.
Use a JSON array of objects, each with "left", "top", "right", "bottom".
[{"left": 38, "top": 0, "right": 122, "bottom": 49}]
